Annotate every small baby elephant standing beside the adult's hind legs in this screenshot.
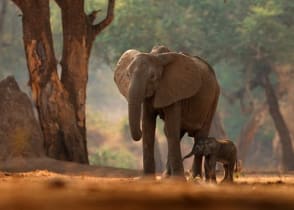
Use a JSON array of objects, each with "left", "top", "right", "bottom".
[{"left": 183, "top": 137, "right": 237, "bottom": 182}]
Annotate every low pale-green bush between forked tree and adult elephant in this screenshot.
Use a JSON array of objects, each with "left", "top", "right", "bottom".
[{"left": 90, "top": 148, "right": 136, "bottom": 169}]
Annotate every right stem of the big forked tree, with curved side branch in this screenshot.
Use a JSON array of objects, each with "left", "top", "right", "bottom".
[{"left": 56, "top": 0, "right": 114, "bottom": 158}]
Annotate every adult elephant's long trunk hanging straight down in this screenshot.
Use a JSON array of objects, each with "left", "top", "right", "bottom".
[{"left": 128, "top": 76, "right": 145, "bottom": 141}]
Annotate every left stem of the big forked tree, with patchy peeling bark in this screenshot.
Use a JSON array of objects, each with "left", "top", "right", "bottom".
[{"left": 10, "top": 0, "right": 88, "bottom": 163}]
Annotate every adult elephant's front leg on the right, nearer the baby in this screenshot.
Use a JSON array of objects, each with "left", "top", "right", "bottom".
[{"left": 164, "top": 103, "right": 184, "bottom": 177}]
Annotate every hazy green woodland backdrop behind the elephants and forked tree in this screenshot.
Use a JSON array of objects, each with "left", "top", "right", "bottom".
[{"left": 0, "top": 0, "right": 294, "bottom": 170}]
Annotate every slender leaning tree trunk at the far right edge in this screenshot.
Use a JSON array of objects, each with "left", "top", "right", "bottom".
[{"left": 262, "top": 73, "right": 294, "bottom": 170}]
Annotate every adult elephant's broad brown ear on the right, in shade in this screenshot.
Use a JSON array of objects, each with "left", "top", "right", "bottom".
[{"left": 154, "top": 53, "right": 202, "bottom": 108}]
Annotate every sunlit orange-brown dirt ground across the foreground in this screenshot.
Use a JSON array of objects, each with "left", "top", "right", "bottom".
[{"left": 0, "top": 169, "right": 294, "bottom": 210}]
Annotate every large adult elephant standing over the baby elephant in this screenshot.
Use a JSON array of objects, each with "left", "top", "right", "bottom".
[{"left": 114, "top": 48, "right": 219, "bottom": 179}]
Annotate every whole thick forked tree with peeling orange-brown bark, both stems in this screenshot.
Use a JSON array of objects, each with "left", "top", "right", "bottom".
[{"left": 12, "top": 0, "right": 115, "bottom": 163}]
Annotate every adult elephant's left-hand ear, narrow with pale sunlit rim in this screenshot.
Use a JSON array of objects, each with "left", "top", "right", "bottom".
[{"left": 114, "top": 49, "right": 140, "bottom": 99}]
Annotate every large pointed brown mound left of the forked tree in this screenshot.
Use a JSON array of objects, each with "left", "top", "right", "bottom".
[{"left": 0, "top": 76, "right": 45, "bottom": 161}]
